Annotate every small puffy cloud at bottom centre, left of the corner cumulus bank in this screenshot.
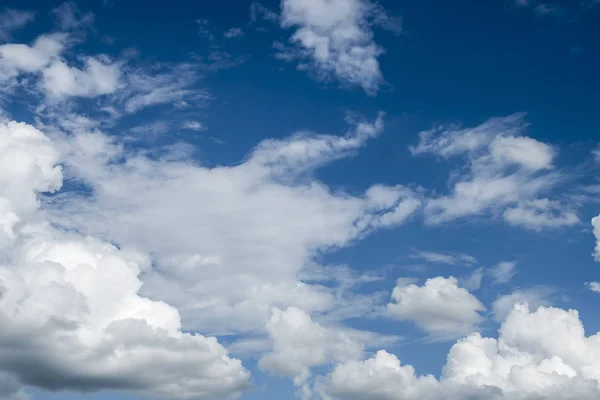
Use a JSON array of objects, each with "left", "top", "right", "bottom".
[{"left": 259, "top": 307, "right": 363, "bottom": 385}]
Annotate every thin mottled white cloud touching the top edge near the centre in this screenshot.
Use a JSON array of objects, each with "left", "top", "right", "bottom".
[{"left": 281, "top": 0, "right": 384, "bottom": 94}]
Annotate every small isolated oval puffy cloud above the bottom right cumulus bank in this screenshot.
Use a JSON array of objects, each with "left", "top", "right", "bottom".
[{"left": 387, "top": 277, "right": 485, "bottom": 339}]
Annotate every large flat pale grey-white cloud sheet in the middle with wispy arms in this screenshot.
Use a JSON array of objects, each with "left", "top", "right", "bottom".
[{"left": 47, "top": 114, "right": 418, "bottom": 340}]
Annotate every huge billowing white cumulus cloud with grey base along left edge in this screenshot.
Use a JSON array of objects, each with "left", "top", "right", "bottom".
[{"left": 0, "top": 122, "right": 249, "bottom": 399}]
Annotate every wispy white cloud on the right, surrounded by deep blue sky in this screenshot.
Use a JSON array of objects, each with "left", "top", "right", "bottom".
[{"left": 410, "top": 114, "right": 579, "bottom": 230}]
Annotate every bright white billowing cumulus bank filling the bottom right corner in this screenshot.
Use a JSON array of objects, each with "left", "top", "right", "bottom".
[{"left": 321, "top": 304, "right": 600, "bottom": 400}]
